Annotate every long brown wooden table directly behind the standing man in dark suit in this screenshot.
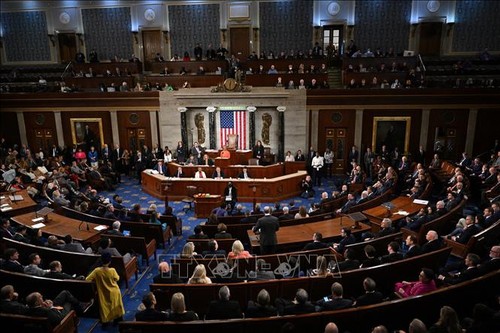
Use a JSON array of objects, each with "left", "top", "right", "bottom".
[{"left": 247, "top": 216, "right": 370, "bottom": 253}]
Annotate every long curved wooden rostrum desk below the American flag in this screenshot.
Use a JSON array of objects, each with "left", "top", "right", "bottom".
[{"left": 141, "top": 170, "right": 307, "bottom": 202}]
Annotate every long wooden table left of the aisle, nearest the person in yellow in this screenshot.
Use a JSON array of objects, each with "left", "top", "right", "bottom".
[{"left": 12, "top": 212, "right": 107, "bottom": 245}]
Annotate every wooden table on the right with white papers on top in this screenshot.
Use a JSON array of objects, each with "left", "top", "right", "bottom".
[{"left": 363, "top": 197, "right": 425, "bottom": 231}]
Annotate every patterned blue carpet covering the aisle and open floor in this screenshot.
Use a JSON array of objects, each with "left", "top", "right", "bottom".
[{"left": 79, "top": 172, "right": 342, "bottom": 333}]
